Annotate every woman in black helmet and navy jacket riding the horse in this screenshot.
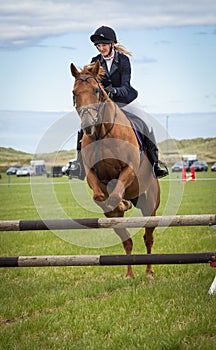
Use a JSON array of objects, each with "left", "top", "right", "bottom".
[{"left": 68, "top": 26, "right": 168, "bottom": 180}]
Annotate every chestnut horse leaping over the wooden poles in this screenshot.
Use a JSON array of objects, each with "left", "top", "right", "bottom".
[{"left": 71, "top": 61, "right": 160, "bottom": 277}]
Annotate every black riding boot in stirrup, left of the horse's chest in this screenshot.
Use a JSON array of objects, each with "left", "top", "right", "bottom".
[{"left": 66, "top": 130, "right": 86, "bottom": 180}]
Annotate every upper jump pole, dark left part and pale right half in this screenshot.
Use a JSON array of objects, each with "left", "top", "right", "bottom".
[{"left": 0, "top": 214, "right": 216, "bottom": 231}]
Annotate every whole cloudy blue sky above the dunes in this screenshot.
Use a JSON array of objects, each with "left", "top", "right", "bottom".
[{"left": 0, "top": 0, "right": 216, "bottom": 152}]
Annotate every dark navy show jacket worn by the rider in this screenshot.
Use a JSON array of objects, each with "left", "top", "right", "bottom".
[{"left": 91, "top": 50, "right": 138, "bottom": 104}]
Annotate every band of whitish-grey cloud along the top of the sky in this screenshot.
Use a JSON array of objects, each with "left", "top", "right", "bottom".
[{"left": 0, "top": 0, "right": 216, "bottom": 49}]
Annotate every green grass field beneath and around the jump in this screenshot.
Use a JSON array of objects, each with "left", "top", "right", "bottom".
[{"left": 0, "top": 171, "right": 216, "bottom": 350}]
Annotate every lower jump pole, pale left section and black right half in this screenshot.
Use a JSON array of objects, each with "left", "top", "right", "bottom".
[{"left": 0, "top": 252, "right": 216, "bottom": 267}]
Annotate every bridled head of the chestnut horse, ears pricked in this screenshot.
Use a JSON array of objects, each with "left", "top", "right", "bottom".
[{"left": 71, "top": 61, "right": 108, "bottom": 135}]
